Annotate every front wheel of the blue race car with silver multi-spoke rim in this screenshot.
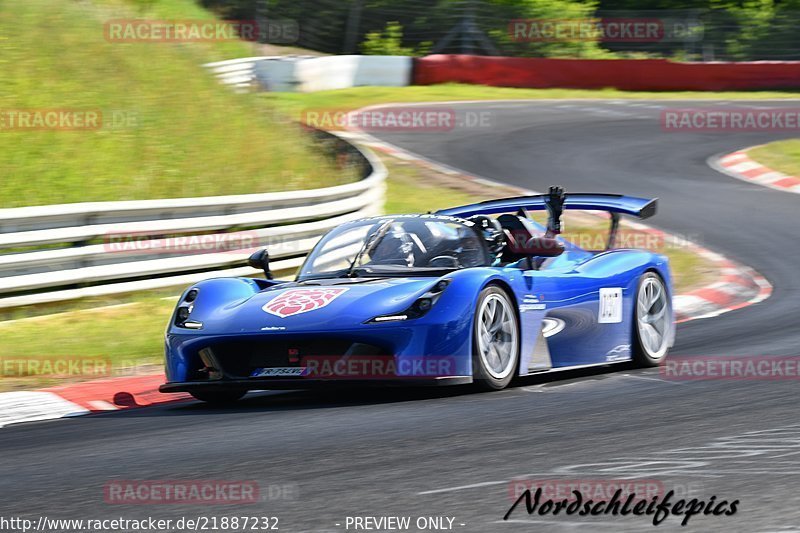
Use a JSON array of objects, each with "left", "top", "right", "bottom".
[{"left": 472, "top": 285, "right": 520, "bottom": 390}]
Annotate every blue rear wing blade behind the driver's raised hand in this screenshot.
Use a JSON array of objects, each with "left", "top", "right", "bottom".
[{"left": 436, "top": 192, "right": 658, "bottom": 220}]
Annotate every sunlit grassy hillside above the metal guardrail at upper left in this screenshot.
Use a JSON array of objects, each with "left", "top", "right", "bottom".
[{"left": 0, "top": 0, "right": 348, "bottom": 208}]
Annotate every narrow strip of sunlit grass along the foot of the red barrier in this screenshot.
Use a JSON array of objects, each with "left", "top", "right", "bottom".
[{"left": 260, "top": 83, "right": 800, "bottom": 117}]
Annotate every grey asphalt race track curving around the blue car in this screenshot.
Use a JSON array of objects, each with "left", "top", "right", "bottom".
[{"left": 0, "top": 101, "right": 800, "bottom": 532}]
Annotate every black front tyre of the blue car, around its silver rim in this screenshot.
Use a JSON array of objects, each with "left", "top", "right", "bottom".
[{"left": 472, "top": 285, "right": 520, "bottom": 390}]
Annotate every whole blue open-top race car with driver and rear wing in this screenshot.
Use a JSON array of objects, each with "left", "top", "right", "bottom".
[{"left": 160, "top": 187, "right": 675, "bottom": 403}]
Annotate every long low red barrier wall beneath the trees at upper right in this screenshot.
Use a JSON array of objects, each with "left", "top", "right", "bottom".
[{"left": 414, "top": 55, "right": 800, "bottom": 91}]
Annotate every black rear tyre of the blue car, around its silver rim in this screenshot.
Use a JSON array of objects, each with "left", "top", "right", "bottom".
[{"left": 632, "top": 272, "right": 674, "bottom": 367}]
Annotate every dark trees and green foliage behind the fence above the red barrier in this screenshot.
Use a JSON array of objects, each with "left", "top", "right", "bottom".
[{"left": 195, "top": 0, "right": 800, "bottom": 61}]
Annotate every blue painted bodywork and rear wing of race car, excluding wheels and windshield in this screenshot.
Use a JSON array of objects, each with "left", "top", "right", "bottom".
[{"left": 162, "top": 195, "right": 674, "bottom": 392}]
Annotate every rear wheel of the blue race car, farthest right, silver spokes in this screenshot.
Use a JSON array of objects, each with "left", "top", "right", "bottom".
[{"left": 633, "top": 272, "right": 672, "bottom": 366}]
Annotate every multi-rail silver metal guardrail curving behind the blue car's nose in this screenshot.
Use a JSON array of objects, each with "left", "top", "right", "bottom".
[{"left": 0, "top": 131, "right": 386, "bottom": 308}]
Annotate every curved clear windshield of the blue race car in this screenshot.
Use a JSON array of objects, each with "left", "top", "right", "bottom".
[{"left": 298, "top": 216, "right": 489, "bottom": 279}]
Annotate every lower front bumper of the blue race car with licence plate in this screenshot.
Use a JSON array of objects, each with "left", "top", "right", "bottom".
[{"left": 161, "top": 325, "right": 472, "bottom": 392}]
